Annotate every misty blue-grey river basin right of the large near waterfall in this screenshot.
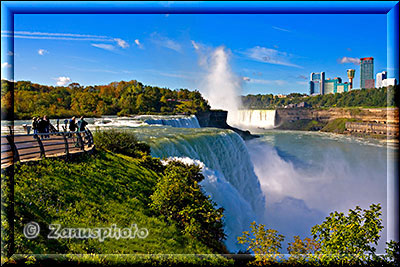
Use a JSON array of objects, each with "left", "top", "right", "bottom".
[{"left": 246, "top": 137, "right": 387, "bottom": 252}]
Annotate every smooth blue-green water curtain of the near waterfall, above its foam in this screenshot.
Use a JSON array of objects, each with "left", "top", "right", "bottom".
[{"left": 148, "top": 130, "right": 265, "bottom": 214}]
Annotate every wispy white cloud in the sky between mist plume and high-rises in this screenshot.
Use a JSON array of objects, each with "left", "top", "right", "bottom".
[{"left": 244, "top": 46, "right": 303, "bottom": 69}]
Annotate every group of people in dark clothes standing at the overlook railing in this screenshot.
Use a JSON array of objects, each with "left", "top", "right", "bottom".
[{"left": 32, "top": 115, "right": 88, "bottom": 139}]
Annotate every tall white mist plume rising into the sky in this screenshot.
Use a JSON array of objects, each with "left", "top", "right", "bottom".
[{"left": 200, "top": 46, "right": 241, "bottom": 124}]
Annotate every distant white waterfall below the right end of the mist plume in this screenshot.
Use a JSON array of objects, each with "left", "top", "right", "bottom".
[{"left": 234, "top": 109, "right": 276, "bottom": 129}]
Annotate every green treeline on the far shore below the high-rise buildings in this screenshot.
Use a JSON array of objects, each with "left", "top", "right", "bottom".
[{"left": 242, "top": 86, "right": 399, "bottom": 109}]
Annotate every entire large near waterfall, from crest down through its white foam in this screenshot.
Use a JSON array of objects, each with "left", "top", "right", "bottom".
[{"left": 142, "top": 128, "right": 265, "bottom": 252}]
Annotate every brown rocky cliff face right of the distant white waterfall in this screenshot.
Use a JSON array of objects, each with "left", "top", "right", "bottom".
[{"left": 275, "top": 108, "right": 399, "bottom": 126}]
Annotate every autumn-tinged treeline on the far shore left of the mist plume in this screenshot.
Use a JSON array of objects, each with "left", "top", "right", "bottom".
[{"left": 1, "top": 80, "right": 210, "bottom": 119}]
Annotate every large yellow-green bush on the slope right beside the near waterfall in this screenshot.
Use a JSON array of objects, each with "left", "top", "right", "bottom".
[{"left": 150, "top": 161, "right": 226, "bottom": 252}]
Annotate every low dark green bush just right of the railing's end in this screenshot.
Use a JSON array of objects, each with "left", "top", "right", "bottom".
[{"left": 93, "top": 129, "right": 150, "bottom": 158}]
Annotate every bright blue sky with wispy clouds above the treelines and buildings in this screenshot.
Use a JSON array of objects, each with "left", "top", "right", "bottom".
[{"left": 2, "top": 14, "right": 387, "bottom": 94}]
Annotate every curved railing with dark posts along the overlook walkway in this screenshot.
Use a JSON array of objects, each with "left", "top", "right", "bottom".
[{"left": 1, "top": 129, "right": 94, "bottom": 168}]
